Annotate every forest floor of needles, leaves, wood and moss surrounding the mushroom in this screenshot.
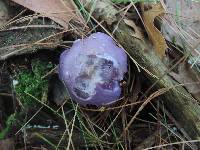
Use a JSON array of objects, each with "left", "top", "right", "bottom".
[{"left": 0, "top": 0, "right": 200, "bottom": 150}]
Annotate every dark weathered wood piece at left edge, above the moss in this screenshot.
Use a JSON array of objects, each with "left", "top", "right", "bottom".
[{"left": 0, "top": 25, "right": 62, "bottom": 60}]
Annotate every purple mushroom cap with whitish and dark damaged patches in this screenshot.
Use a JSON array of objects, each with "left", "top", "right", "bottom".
[{"left": 59, "top": 32, "right": 127, "bottom": 106}]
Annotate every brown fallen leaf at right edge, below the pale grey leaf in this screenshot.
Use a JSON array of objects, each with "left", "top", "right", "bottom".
[{"left": 170, "top": 63, "right": 200, "bottom": 102}]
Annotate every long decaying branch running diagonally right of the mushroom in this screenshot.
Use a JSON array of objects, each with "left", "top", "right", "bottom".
[{"left": 84, "top": 0, "right": 200, "bottom": 139}]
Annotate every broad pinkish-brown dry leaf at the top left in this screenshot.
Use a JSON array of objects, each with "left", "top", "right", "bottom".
[{"left": 12, "top": 0, "right": 84, "bottom": 29}]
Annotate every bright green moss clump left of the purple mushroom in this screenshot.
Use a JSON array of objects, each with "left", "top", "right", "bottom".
[{"left": 15, "top": 59, "right": 54, "bottom": 108}]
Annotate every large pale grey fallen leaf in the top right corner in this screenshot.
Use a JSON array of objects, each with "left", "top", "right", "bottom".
[{"left": 161, "top": 0, "right": 200, "bottom": 67}]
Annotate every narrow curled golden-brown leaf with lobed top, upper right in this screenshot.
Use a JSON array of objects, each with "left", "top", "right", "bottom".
[{"left": 142, "top": 3, "right": 167, "bottom": 58}]
